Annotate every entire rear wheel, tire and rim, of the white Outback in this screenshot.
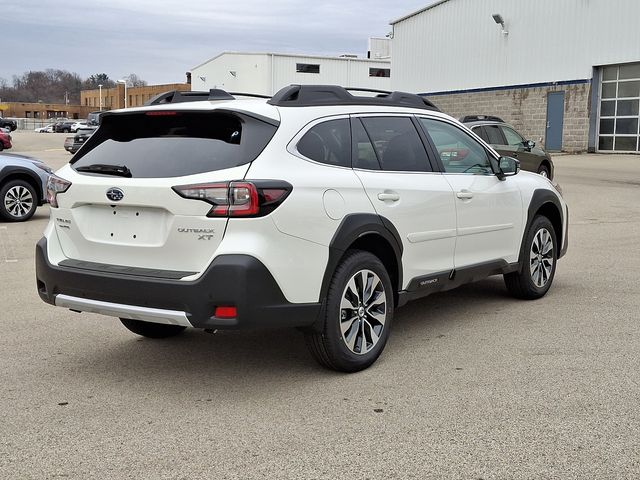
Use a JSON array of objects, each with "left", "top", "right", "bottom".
[{"left": 305, "top": 250, "right": 394, "bottom": 372}]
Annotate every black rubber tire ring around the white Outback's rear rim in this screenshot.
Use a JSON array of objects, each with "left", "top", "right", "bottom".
[{"left": 324, "top": 252, "right": 394, "bottom": 371}]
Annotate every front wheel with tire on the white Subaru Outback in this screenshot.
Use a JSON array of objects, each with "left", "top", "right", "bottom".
[{"left": 504, "top": 215, "right": 558, "bottom": 300}]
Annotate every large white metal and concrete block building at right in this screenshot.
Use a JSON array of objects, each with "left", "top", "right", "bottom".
[{"left": 391, "top": 0, "right": 640, "bottom": 153}]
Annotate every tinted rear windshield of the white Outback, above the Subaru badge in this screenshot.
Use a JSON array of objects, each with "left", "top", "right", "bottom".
[{"left": 71, "top": 111, "right": 277, "bottom": 178}]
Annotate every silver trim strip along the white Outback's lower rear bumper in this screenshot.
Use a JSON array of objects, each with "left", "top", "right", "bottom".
[{"left": 55, "top": 294, "right": 192, "bottom": 327}]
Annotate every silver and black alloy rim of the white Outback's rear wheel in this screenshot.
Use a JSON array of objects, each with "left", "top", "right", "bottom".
[{"left": 340, "top": 270, "right": 387, "bottom": 355}]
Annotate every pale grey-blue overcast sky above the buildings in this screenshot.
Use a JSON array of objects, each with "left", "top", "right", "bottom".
[{"left": 0, "top": 0, "right": 434, "bottom": 84}]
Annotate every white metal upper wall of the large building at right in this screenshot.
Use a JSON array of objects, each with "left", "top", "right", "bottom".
[{"left": 392, "top": 0, "right": 640, "bottom": 93}]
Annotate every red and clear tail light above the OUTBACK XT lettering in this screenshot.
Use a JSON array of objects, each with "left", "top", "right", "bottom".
[{"left": 173, "top": 180, "right": 292, "bottom": 217}]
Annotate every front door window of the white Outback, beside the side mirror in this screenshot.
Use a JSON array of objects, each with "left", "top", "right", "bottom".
[{"left": 420, "top": 118, "right": 493, "bottom": 175}]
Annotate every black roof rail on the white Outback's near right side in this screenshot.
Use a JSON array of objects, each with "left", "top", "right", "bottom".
[{"left": 267, "top": 85, "right": 439, "bottom": 111}]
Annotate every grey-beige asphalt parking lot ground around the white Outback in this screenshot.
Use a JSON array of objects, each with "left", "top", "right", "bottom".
[{"left": 0, "top": 132, "right": 640, "bottom": 479}]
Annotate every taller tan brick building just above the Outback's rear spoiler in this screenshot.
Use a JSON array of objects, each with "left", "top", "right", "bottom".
[{"left": 80, "top": 83, "right": 191, "bottom": 111}]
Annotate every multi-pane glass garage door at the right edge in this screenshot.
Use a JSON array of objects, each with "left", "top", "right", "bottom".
[{"left": 598, "top": 63, "right": 640, "bottom": 152}]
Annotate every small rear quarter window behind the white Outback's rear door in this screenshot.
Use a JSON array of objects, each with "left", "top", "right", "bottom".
[{"left": 297, "top": 118, "right": 351, "bottom": 167}]
